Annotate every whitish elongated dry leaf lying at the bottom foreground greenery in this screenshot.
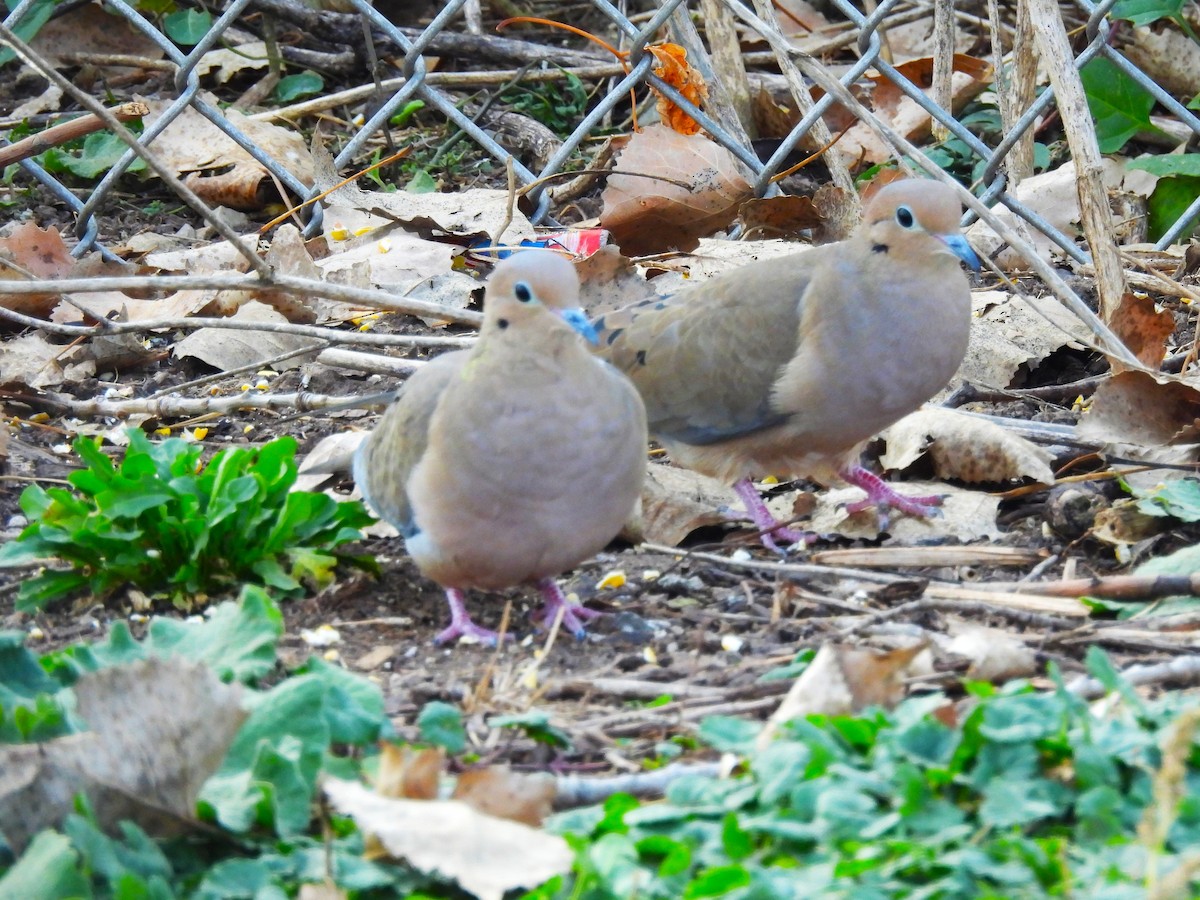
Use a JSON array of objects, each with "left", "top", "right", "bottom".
[{"left": 324, "top": 778, "right": 574, "bottom": 900}]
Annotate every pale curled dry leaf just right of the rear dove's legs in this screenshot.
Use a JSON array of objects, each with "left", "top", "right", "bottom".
[{"left": 880, "top": 407, "right": 1054, "bottom": 485}]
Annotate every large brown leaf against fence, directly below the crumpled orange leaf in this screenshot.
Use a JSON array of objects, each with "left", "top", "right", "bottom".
[{"left": 600, "top": 125, "right": 751, "bottom": 256}]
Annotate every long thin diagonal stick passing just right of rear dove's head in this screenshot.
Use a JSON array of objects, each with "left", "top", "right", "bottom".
[{"left": 732, "top": 4, "right": 1145, "bottom": 370}]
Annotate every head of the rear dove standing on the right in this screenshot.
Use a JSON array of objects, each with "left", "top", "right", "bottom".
[{"left": 863, "top": 179, "right": 979, "bottom": 271}]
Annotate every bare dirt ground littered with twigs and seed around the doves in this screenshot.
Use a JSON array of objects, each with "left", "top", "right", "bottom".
[{"left": 0, "top": 321, "right": 1198, "bottom": 769}]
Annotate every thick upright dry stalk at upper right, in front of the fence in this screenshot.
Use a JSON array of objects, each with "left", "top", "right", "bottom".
[{"left": 1028, "top": 0, "right": 1123, "bottom": 324}]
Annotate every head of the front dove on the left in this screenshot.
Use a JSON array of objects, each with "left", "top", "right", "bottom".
[{"left": 484, "top": 250, "right": 596, "bottom": 343}]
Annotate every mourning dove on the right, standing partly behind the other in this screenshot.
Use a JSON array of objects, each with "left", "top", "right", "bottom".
[{"left": 594, "top": 180, "right": 979, "bottom": 550}]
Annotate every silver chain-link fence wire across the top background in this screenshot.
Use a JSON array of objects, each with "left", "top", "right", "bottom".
[{"left": 0, "top": 0, "right": 1200, "bottom": 263}]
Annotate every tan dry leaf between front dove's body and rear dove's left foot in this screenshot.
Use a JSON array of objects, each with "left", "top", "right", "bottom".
[{"left": 622, "top": 466, "right": 737, "bottom": 547}]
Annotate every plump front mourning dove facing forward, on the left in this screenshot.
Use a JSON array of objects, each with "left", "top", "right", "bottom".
[{"left": 354, "top": 251, "right": 647, "bottom": 643}]
